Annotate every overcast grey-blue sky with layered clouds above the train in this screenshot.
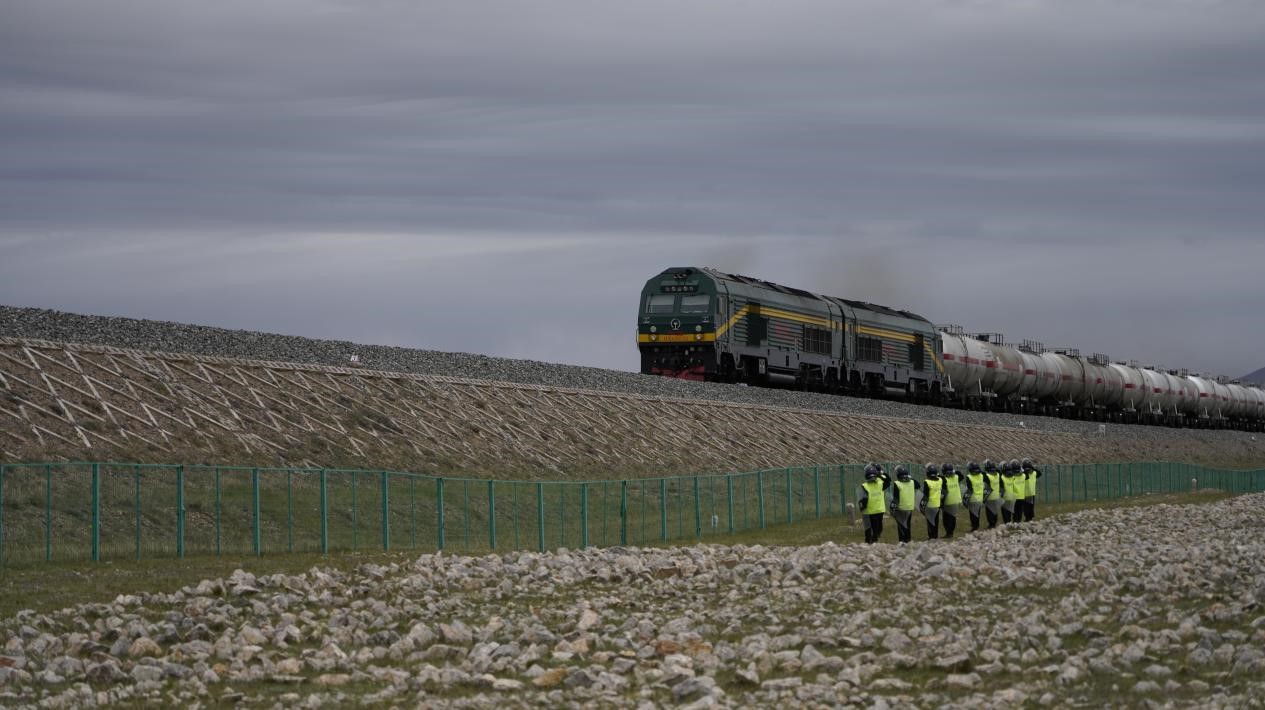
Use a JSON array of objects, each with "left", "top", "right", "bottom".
[{"left": 0, "top": 0, "right": 1265, "bottom": 376}]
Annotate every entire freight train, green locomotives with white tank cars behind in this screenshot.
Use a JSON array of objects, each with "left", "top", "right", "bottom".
[{"left": 636, "top": 267, "right": 1265, "bottom": 432}]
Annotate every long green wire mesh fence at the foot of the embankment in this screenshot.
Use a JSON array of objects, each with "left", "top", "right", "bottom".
[{"left": 0, "top": 462, "right": 1265, "bottom": 566}]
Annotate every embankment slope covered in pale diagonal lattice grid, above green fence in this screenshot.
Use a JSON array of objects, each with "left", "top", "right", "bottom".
[{"left": 0, "top": 338, "right": 1265, "bottom": 478}]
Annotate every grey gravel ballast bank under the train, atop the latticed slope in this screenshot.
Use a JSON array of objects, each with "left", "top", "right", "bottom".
[{"left": 0, "top": 305, "right": 1236, "bottom": 443}]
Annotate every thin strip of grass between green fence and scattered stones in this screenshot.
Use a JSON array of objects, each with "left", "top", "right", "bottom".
[{"left": 0, "top": 490, "right": 1230, "bottom": 619}]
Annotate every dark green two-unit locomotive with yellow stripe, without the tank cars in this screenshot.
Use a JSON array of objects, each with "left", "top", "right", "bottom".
[{"left": 638, "top": 267, "right": 944, "bottom": 401}]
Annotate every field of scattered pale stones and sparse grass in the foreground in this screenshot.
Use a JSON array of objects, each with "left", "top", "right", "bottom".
[{"left": 0, "top": 495, "right": 1265, "bottom": 709}]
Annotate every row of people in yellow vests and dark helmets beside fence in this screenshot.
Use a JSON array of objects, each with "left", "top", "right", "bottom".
[{"left": 856, "top": 458, "right": 1041, "bottom": 544}]
